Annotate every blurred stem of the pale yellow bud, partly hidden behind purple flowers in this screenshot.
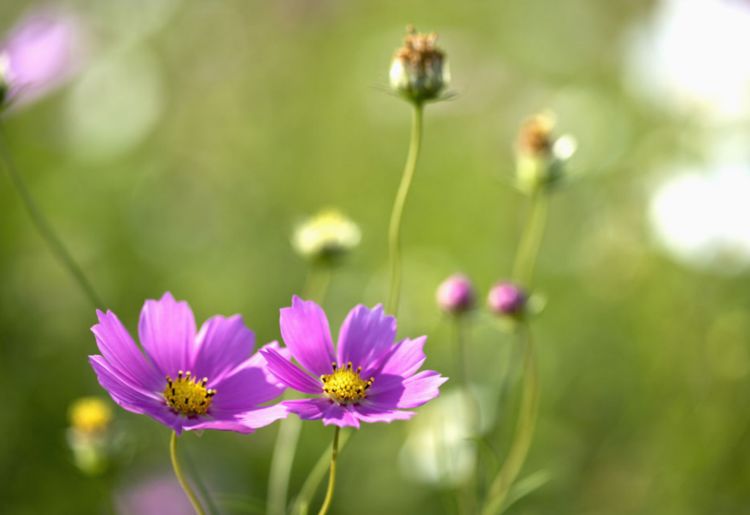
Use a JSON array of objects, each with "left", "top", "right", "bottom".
[{"left": 266, "top": 264, "right": 331, "bottom": 515}]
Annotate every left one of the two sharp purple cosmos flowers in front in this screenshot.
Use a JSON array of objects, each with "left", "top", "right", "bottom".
[{"left": 89, "top": 293, "right": 288, "bottom": 434}]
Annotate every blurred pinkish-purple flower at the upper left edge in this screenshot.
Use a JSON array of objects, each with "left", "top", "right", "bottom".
[{"left": 0, "top": 9, "right": 83, "bottom": 108}]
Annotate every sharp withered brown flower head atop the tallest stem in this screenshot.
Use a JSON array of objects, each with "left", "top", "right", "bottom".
[{"left": 390, "top": 26, "right": 450, "bottom": 104}]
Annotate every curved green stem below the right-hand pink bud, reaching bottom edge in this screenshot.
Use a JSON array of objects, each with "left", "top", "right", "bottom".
[{"left": 482, "top": 325, "right": 539, "bottom": 515}]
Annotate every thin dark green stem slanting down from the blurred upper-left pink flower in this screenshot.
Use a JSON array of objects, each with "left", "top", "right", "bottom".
[{"left": 0, "top": 127, "right": 104, "bottom": 308}]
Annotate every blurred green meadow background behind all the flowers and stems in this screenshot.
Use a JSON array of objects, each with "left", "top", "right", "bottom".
[{"left": 0, "top": 0, "right": 750, "bottom": 515}]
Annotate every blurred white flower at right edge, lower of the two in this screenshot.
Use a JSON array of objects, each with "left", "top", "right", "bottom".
[{"left": 649, "top": 162, "right": 750, "bottom": 274}]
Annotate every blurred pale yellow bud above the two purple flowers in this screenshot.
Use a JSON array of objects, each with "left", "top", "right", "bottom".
[{"left": 292, "top": 209, "right": 362, "bottom": 263}]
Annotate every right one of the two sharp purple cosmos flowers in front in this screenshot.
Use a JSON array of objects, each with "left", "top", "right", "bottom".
[{"left": 261, "top": 296, "right": 447, "bottom": 428}]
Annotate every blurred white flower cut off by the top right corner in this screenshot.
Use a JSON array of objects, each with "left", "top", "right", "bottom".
[{"left": 627, "top": 0, "right": 750, "bottom": 120}]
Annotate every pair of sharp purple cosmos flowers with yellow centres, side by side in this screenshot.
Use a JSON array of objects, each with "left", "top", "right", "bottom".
[{"left": 89, "top": 293, "right": 447, "bottom": 434}]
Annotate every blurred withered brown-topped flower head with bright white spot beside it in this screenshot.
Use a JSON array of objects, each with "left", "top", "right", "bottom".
[{"left": 516, "top": 113, "right": 575, "bottom": 194}]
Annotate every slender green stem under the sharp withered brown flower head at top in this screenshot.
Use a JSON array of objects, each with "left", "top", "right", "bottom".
[{"left": 386, "top": 103, "right": 423, "bottom": 315}]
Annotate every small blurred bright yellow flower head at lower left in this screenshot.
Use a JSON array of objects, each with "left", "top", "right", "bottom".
[{"left": 68, "top": 397, "right": 112, "bottom": 475}]
